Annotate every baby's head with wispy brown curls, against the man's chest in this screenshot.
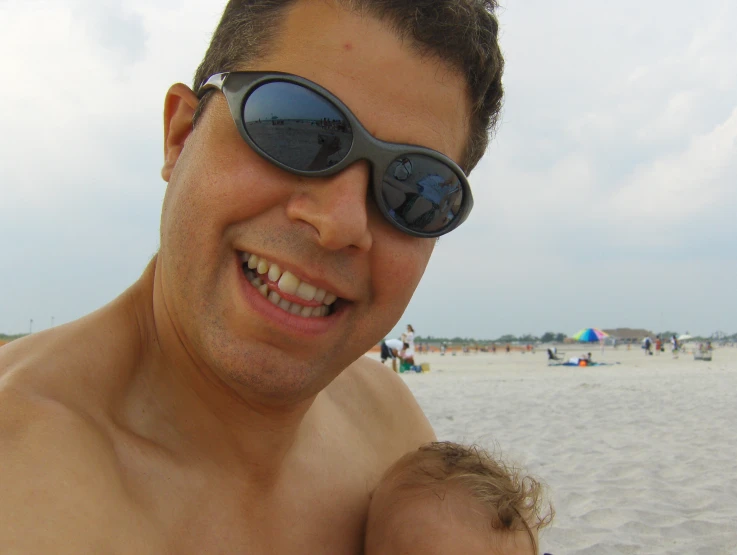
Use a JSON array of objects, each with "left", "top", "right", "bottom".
[{"left": 365, "top": 442, "right": 553, "bottom": 555}]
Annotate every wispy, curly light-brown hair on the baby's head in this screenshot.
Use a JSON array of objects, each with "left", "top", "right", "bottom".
[{"left": 382, "top": 441, "right": 555, "bottom": 553}]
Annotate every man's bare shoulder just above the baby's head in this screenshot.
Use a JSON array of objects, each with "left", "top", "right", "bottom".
[{"left": 328, "top": 357, "right": 435, "bottom": 454}]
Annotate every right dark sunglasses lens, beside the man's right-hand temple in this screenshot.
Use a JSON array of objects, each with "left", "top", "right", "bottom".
[{"left": 381, "top": 154, "right": 463, "bottom": 235}]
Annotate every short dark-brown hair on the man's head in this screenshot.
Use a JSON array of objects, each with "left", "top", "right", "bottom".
[{"left": 193, "top": 0, "right": 504, "bottom": 173}]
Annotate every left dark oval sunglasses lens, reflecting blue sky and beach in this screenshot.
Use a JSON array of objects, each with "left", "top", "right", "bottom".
[{"left": 243, "top": 81, "right": 353, "bottom": 171}]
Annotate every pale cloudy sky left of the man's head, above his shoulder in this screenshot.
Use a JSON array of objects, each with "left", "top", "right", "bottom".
[{"left": 0, "top": 0, "right": 222, "bottom": 332}]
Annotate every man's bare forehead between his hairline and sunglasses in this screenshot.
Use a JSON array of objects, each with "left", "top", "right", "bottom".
[{"left": 242, "top": 1, "right": 470, "bottom": 162}]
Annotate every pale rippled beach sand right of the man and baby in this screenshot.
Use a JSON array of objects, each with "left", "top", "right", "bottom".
[{"left": 366, "top": 346, "right": 737, "bottom": 555}]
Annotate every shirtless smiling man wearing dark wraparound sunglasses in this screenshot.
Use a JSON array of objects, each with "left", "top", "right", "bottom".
[{"left": 0, "top": 0, "right": 503, "bottom": 555}]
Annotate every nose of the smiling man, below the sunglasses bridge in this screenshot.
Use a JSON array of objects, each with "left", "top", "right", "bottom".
[{"left": 287, "top": 161, "right": 373, "bottom": 251}]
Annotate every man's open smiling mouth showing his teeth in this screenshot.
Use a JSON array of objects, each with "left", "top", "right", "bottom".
[{"left": 240, "top": 252, "right": 339, "bottom": 318}]
